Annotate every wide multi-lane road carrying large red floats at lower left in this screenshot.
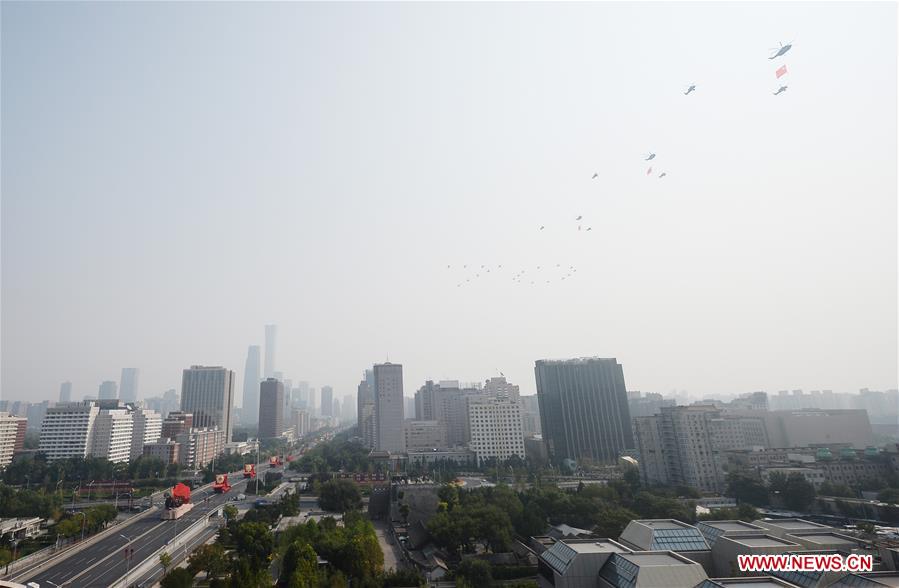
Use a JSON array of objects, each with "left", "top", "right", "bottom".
[{"left": 20, "top": 467, "right": 267, "bottom": 588}]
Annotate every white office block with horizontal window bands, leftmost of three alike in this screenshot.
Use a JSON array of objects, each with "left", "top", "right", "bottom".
[{"left": 39, "top": 401, "right": 100, "bottom": 461}]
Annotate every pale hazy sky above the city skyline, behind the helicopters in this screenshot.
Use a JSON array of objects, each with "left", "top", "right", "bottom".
[{"left": 2, "top": 2, "right": 899, "bottom": 400}]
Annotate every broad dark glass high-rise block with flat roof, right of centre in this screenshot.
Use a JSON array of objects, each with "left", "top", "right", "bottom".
[{"left": 534, "top": 357, "right": 634, "bottom": 463}]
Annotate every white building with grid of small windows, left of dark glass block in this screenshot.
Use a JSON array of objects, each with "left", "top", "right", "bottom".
[{"left": 468, "top": 394, "right": 525, "bottom": 464}]
